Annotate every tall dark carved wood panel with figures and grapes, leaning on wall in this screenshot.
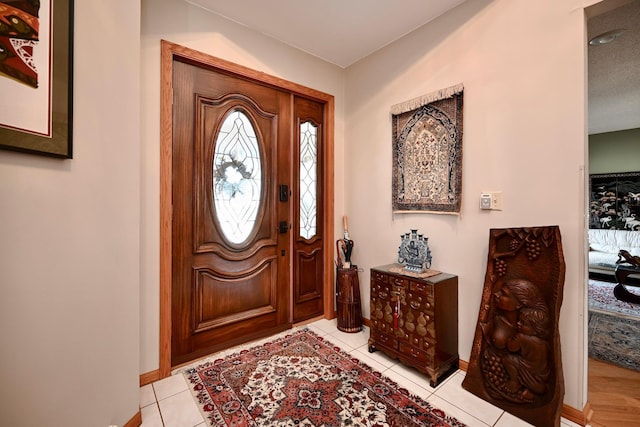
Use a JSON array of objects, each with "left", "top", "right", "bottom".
[{"left": 462, "top": 226, "right": 565, "bottom": 427}]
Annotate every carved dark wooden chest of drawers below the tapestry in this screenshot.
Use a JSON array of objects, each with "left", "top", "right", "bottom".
[{"left": 369, "top": 264, "right": 459, "bottom": 387}]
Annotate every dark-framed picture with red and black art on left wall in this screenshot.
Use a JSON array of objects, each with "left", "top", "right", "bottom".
[{"left": 0, "top": 0, "right": 73, "bottom": 159}]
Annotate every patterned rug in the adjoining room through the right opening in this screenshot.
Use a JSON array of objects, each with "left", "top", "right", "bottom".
[{"left": 589, "top": 280, "right": 640, "bottom": 371}]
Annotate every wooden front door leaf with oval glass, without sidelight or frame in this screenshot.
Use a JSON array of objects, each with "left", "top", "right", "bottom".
[{"left": 171, "top": 57, "right": 292, "bottom": 365}]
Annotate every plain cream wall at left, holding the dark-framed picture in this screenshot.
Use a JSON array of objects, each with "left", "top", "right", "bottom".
[{"left": 0, "top": 0, "right": 140, "bottom": 427}]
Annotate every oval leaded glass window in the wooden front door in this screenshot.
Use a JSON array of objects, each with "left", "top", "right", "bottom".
[{"left": 213, "top": 110, "right": 262, "bottom": 244}]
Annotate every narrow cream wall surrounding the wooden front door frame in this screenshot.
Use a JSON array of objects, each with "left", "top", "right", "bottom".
[{"left": 140, "top": 0, "right": 345, "bottom": 373}]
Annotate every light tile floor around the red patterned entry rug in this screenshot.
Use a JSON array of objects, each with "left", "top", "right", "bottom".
[{"left": 140, "top": 319, "right": 578, "bottom": 427}]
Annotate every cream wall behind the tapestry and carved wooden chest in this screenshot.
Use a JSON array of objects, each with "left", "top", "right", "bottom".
[{"left": 345, "top": 0, "right": 586, "bottom": 409}]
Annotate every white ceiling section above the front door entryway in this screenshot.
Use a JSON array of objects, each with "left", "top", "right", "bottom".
[{"left": 186, "top": 0, "right": 465, "bottom": 68}]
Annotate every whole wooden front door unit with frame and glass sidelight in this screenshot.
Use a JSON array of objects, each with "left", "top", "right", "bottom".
[{"left": 168, "top": 46, "right": 334, "bottom": 368}]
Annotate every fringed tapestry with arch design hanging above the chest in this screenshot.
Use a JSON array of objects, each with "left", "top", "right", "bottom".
[{"left": 391, "top": 84, "right": 463, "bottom": 214}]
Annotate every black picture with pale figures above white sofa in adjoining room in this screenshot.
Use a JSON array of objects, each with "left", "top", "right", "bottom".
[{"left": 589, "top": 172, "right": 640, "bottom": 230}]
